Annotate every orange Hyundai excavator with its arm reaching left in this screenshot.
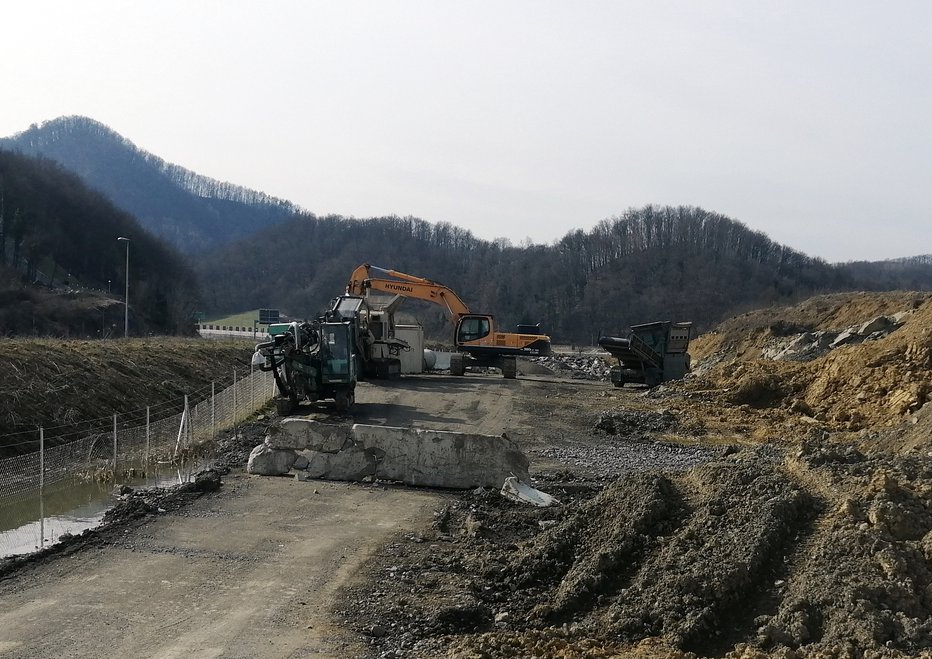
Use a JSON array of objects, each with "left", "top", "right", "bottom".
[{"left": 346, "top": 263, "right": 551, "bottom": 379}]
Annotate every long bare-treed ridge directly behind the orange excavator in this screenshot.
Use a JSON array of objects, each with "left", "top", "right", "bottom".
[{"left": 197, "top": 206, "right": 932, "bottom": 344}]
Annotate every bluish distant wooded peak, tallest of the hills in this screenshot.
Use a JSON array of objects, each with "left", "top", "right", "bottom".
[{"left": 0, "top": 117, "right": 296, "bottom": 254}]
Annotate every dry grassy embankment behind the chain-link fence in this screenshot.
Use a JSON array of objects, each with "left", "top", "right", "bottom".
[{"left": 0, "top": 337, "right": 252, "bottom": 456}]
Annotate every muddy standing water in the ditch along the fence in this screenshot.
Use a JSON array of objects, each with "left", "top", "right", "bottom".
[{"left": 0, "top": 463, "right": 201, "bottom": 558}]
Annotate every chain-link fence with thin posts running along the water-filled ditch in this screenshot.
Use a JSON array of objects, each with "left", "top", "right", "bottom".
[{"left": 0, "top": 371, "right": 275, "bottom": 556}]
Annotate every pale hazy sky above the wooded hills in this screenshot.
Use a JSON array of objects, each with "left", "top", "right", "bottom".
[{"left": 0, "top": 0, "right": 932, "bottom": 262}]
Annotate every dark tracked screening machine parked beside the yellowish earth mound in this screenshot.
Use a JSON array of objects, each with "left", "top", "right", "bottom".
[{"left": 599, "top": 321, "right": 692, "bottom": 387}]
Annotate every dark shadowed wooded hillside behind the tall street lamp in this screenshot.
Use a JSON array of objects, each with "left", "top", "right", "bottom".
[{"left": 0, "top": 150, "right": 198, "bottom": 337}]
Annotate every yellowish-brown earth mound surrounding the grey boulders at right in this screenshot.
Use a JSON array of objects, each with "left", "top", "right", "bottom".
[{"left": 670, "top": 293, "right": 932, "bottom": 447}]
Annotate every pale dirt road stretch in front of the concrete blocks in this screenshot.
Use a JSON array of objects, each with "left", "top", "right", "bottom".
[{"left": 0, "top": 475, "right": 438, "bottom": 657}]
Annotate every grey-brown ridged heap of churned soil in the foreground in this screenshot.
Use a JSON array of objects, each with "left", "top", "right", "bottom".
[{"left": 336, "top": 442, "right": 932, "bottom": 658}]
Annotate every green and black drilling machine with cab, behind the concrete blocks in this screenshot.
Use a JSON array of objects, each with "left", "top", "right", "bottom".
[{"left": 253, "top": 319, "right": 357, "bottom": 415}]
